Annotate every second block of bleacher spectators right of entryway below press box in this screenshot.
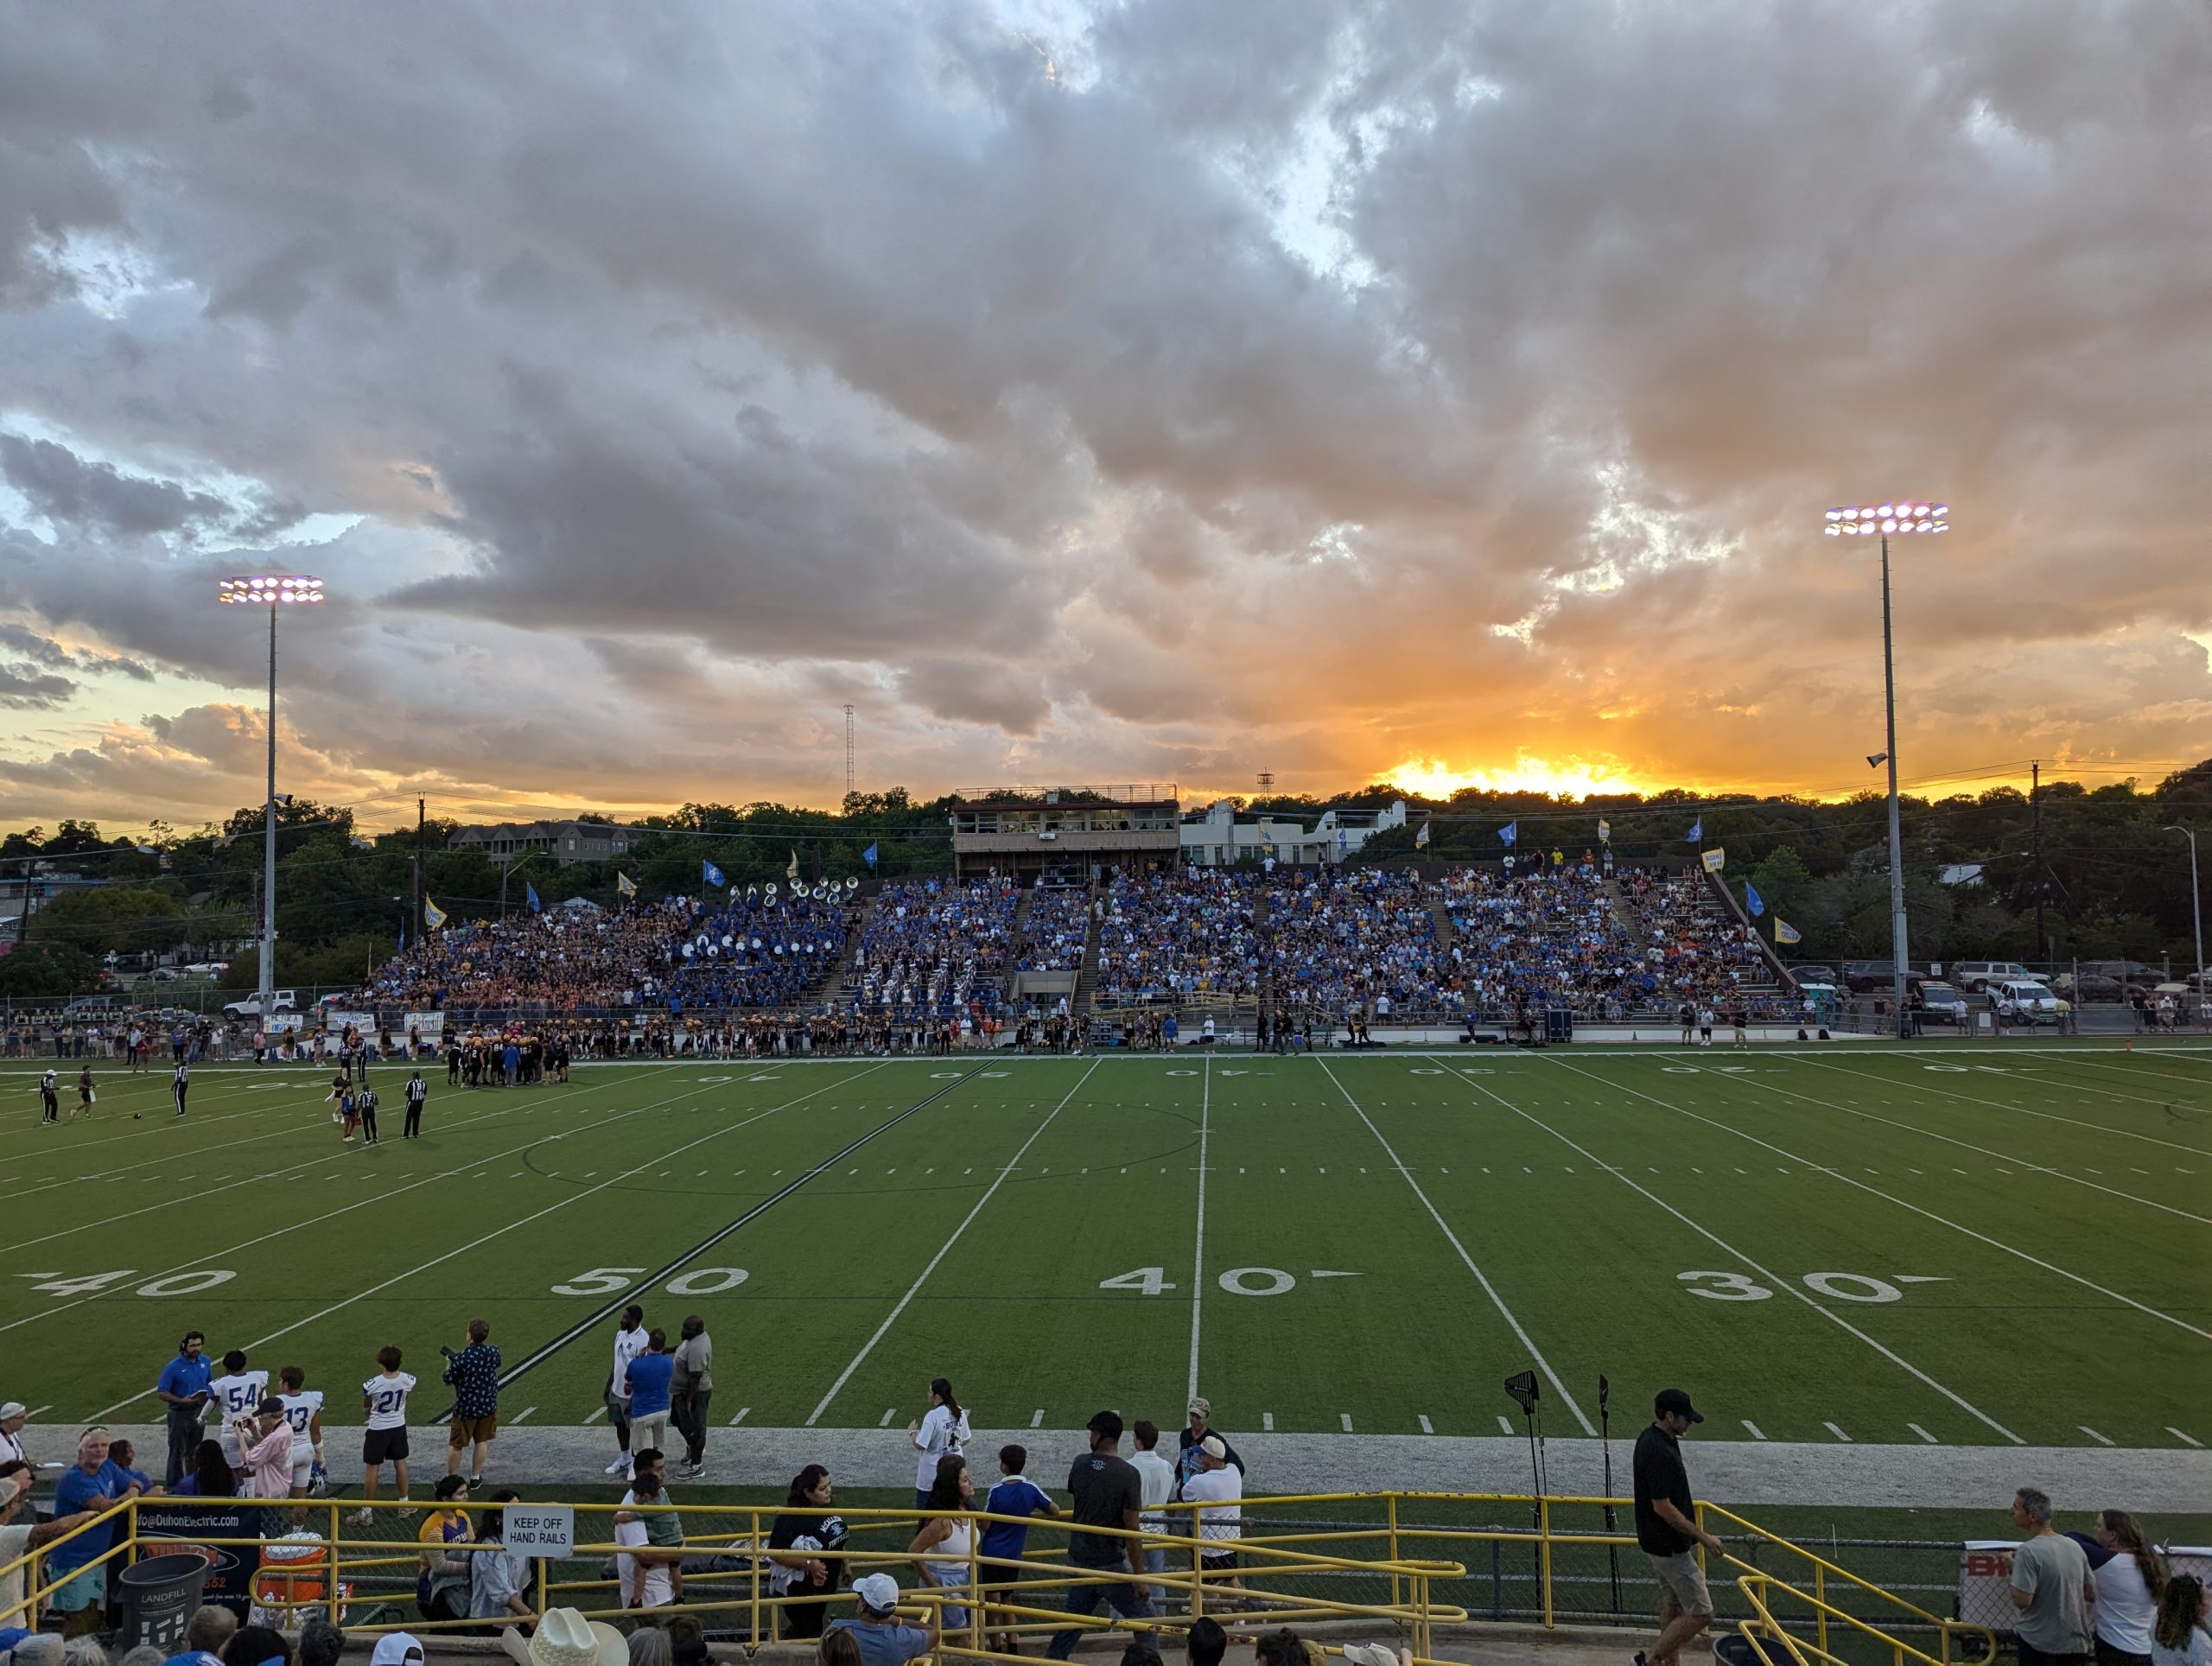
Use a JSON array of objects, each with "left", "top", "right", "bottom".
[{"left": 1263, "top": 868, "right": 1451, "bottom": 1018}]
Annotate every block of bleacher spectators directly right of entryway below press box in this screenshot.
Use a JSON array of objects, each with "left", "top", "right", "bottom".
[{"left": 1093, "top": 868, "right": 1261, "bottom": 1007}]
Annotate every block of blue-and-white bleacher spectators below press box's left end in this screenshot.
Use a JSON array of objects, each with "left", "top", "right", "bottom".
[{"left": 845, "top": 878, "right": 1022, "bottom": 1020}]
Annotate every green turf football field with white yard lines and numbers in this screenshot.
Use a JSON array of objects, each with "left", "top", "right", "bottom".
[{"left": 0, "top": 1042, "right": 2212, "bottom": 1449}]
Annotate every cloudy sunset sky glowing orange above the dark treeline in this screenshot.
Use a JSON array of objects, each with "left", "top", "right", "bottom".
[{"left": 0, "top": 0, "right": 2212, "bottom": 828}]
